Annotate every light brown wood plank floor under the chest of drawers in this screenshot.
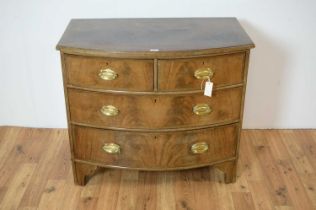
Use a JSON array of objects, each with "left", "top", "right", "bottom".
[{"left": 0, "top": 127, "right": 316, "bottom": 210}]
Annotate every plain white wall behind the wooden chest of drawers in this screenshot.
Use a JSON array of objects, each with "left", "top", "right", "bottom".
[{"left": 0, "top": 0, "right": 316, "bottom": 128}]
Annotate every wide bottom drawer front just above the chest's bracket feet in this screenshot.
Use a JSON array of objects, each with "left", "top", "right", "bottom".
[{"left": 73, "top": 124, "right": 238, "bottom": 170}]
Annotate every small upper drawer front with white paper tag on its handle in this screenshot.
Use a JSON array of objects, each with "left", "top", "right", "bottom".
[{"left": 158, "top": 53, "right": 245, "bottom": 91}]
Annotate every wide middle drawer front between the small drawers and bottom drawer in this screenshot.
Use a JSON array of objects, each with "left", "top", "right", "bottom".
[{"left": 68, "top": 87, "right": 242, "bottom": 128}]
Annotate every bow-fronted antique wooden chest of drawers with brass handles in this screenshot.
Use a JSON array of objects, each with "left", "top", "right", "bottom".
[{"left": 57, "top": 18, "right": 254, "bottom": 185}]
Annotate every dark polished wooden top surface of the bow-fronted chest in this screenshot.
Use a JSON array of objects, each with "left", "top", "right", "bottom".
[{"left": 57, "top": 18, "right": 254, "bottom": 55}]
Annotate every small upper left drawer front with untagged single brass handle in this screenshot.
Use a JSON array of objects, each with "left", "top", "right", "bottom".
[{"left": 65, "top": 55, "right": 154, "bottom": 91}]
